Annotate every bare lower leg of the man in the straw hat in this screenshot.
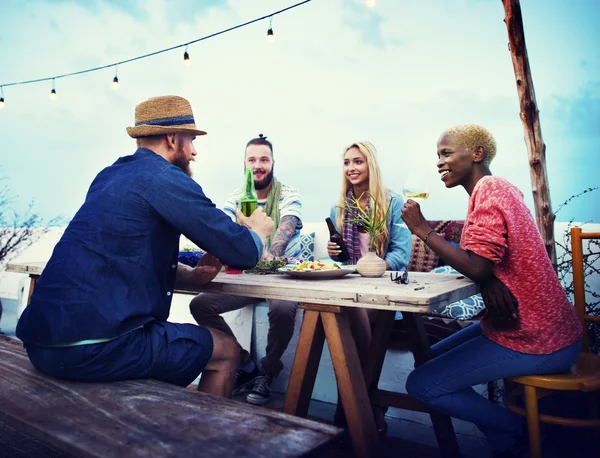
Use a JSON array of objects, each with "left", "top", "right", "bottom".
[{"left": 198, "top": 328, "right": 241, "bottom": 398}]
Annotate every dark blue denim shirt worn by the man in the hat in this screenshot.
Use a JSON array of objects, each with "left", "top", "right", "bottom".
[{"left": 17, "top": 148, "right": 263, "bottom": 346}]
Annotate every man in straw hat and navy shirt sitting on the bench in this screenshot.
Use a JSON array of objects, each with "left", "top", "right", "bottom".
[{"left": 17, "top": 96, "right": 273, "bottom": 396}]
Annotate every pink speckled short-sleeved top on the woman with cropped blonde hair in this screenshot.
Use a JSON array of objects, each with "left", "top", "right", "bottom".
[{"left": 460, "top": 176, "right": 582, "bottom": 355}]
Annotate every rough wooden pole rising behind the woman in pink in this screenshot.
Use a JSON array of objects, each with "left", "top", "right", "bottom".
[{"left": 502, "top": 0, "right": 556, "bottom": 266}]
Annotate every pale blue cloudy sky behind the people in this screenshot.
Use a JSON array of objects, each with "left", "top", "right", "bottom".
[{"left": 0, "top": 0, "right": 600, "bottom": 229}]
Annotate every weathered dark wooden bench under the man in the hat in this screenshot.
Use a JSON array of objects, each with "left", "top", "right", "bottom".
[{"left": 0, "top": 336, "right": 342, "bottom": 458}]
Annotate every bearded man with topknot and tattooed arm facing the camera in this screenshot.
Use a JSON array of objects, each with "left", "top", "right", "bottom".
[{"left": 190, "top": 134, "right": 302, "bottom": 405}]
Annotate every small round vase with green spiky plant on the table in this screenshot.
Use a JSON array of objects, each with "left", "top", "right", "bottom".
[{"left": 343, "top": 192, "right": 394, "bottom": 277}]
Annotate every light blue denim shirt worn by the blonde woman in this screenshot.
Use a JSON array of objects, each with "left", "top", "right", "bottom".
[{"left": 330, "top": 191, "right": 412, "bottom": 270}]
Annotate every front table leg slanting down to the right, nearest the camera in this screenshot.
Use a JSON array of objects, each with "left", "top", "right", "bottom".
[{"left": 321, "top": 311, "right": 379, "bottom": 457}]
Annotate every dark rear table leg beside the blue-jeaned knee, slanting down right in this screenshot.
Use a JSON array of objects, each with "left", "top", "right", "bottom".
[{"left": 402, "top": 312, "right": 460, "bottom": 458}]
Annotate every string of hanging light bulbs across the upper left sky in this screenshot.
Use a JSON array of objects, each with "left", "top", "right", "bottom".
[{"left": 0, "top": 0, "right": 312, "bottom": 103}]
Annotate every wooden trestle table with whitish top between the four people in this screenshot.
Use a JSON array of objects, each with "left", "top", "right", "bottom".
[{"left": 7, "top": 263, "right": 478, "bottom": 457}]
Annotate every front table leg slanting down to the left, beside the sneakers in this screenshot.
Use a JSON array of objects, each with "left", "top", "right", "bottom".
[{"left": 283, "top": 310, "right": 325, "bottom": 417}]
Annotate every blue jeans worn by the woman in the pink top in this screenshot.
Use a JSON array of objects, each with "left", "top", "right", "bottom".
[{"left": 406, "top": 323, "right": 581, "bottom": 452}]
